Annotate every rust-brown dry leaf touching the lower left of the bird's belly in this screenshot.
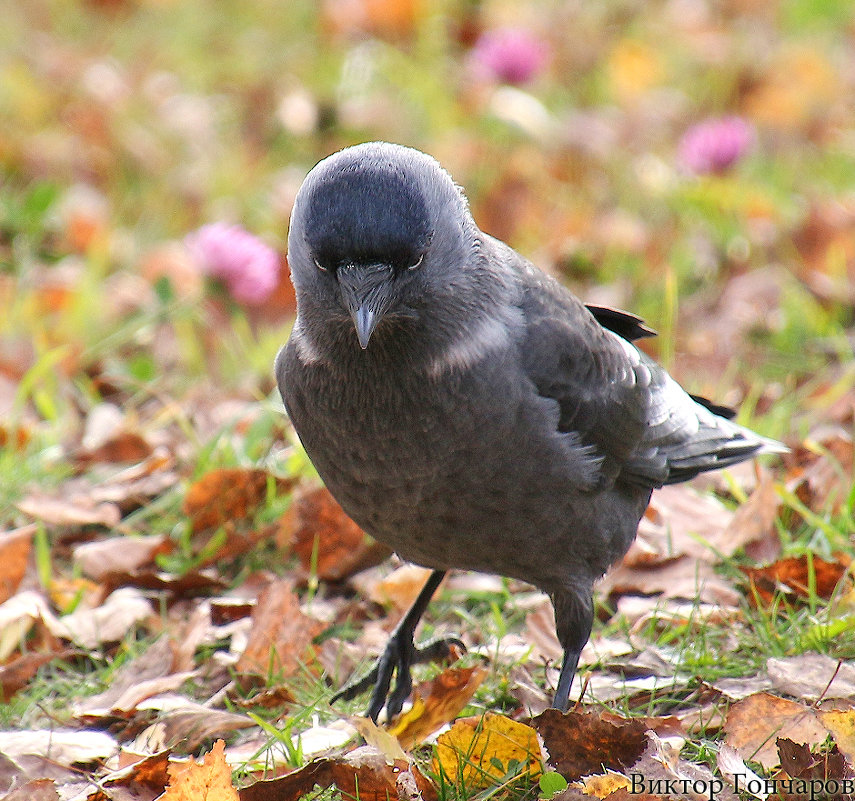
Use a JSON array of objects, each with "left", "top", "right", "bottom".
[{"left": 281, "top": 487, "right": 391, "bottom": 581}]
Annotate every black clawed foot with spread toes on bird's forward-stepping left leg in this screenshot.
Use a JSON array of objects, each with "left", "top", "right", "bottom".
[{"left": 330, "top": 631, "right": 466, "bottom": 723}]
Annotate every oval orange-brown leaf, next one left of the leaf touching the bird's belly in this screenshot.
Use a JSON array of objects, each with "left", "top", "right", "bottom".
[{"left": 183, "top": 467, "right": 280, "bottom": 533}]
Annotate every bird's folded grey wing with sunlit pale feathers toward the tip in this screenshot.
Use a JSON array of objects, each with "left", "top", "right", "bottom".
[{"left": 521, "top": 256, "right": 782, "bottom": 486}]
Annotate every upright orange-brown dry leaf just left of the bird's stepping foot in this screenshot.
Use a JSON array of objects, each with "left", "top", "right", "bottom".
[{"left": 235, "top": 579, "right": 325, "bottom": 679}]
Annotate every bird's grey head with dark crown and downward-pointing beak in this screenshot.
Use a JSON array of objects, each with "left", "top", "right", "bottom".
[{"left": 288, "top": 142, "right": 480, "bottom": 349}]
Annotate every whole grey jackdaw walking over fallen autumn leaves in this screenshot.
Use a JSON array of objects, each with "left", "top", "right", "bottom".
[{"left": 275, "top": 142, "right": 786, "bottom": 722}]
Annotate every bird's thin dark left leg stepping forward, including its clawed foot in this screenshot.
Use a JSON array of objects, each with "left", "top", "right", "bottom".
[{"left": 330, "top": 570, "right": 465, "bottom": 722}]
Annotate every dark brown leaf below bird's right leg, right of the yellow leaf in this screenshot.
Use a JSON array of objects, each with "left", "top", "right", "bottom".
[{"left": 531, "top": 709, "right": 648, "bottom": 781}]
